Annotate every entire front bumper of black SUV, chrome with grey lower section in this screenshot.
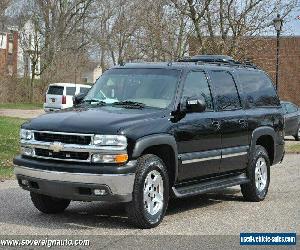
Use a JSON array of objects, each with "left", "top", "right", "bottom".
[{"left": 14, "top": 166, "right": 135, "bottom": 202}]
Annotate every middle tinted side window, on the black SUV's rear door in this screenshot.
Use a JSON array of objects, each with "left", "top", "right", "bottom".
[{"left": 211, "top": 71, "right": 241, "bottom": 110}]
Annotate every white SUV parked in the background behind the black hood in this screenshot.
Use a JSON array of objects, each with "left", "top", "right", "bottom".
[{"left": 44, "top": 83, "right": 91, "bottom": 112}]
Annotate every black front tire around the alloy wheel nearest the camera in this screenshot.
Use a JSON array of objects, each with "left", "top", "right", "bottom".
[{"left": 126, "top": 154, "right": 169, "bottom": 229}]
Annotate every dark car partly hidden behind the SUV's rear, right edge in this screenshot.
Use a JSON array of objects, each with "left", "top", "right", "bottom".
[{"left": 281, "top": 101, "right": 300, "bottom": 141}]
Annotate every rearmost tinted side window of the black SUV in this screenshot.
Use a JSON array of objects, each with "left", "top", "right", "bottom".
[{"left": 239, "top": 71, "right": 279, "bottom": 107}]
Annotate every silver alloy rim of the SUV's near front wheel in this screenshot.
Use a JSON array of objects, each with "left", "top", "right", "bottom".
[{"left": 144, "top": 170, "right": 164, "bottom": 215}]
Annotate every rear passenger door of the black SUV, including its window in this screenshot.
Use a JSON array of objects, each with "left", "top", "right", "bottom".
[{"left": 210, "top": 70, "right": 249, "bottom": 172}]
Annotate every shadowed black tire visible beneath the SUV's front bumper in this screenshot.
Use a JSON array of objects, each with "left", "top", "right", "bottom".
[{"left": 30, "top": 192, "right": 70, "bottom": 214}]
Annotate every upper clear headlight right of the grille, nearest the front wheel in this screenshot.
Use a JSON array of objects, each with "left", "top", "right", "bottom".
[{"left": 93, "top": 135, "right": 127, "bottom": 150}]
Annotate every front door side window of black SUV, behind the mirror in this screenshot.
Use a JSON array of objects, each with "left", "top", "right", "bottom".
[{"left": 182, "top": 71, "right": 213, "bottom": 110}]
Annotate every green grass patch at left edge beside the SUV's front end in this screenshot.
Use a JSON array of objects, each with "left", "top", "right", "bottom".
[{"left": 0, "top": 116, "right": 26, "bottom": 180}]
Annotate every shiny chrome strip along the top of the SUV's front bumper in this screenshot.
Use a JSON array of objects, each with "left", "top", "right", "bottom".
[{"left": 14, "top": 166, "right": 135, "bottom": 195}]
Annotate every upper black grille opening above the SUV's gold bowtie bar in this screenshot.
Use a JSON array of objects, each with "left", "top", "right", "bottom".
[{"left": 34, "top": 132, "right": 91, "bottom": 145}]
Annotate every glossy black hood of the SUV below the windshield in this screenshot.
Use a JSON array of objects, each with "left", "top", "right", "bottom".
[{"left": 22, "top": 106, "right": 168, "bottom": 134}]
